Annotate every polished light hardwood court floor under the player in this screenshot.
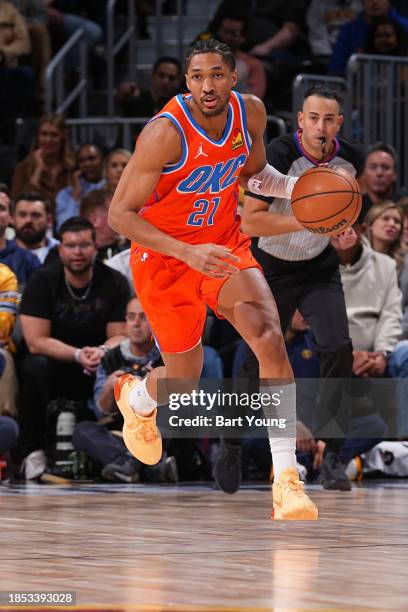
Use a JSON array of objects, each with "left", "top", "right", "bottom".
[{"left": 0, "top": 480, "right": 408, "bottom": 612}]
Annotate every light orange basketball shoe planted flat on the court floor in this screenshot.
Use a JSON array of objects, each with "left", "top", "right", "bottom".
[{"left": 271, "top": 468, "right": 318, "bottom": 521}]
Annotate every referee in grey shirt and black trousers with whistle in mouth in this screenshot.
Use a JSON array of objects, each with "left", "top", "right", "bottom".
[{"left": 215, "top": 86, "right": 364, "bottom": 493}]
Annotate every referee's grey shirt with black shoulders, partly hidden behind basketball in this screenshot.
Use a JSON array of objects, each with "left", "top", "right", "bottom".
[{"left": 249, "top": 132, "right": 365, "bottom": 261}]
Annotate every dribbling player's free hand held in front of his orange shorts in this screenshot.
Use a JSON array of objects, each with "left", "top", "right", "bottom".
[{"left": 183, "top": 244, "right": 240, "bottom": 278}]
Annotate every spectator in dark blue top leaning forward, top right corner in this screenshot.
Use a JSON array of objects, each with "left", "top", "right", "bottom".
[{"left": 329, "top": 0, "right": 408, "bottom": 76}]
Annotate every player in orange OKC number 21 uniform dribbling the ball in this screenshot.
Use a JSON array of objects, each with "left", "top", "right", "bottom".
[{"left": 110, "top": 40, "right": 317, "bottom": 520}]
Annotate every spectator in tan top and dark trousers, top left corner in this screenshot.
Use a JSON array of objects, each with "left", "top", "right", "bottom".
[{"left": 0, "top": 0, "right": 34, "bottom": 138}]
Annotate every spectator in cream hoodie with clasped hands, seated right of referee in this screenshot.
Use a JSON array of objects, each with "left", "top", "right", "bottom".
[{"left": 333, "top": 222, "right": 408, "bottom": 436}]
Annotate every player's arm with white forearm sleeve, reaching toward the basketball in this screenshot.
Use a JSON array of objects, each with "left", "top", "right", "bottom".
[{"left": 240, "top": 95, "right": 297, "bottom": 198}]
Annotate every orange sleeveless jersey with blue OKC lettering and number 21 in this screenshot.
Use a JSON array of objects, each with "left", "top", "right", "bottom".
[{"left": 139, "top": 91, "right": 251, "bottom": 244}]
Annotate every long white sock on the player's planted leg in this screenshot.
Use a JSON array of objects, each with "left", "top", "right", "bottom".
[{"left": 260, "top": 383, "right": 296, "bottom": 480}]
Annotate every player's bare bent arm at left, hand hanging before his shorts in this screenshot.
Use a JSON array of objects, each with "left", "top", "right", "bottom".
[{"left": 109, "top": 118, "right": 238, "bottom": 278}]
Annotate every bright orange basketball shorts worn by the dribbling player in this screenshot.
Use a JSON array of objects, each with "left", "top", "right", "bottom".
[{"left": 130, "top": 232, "right": 262, "bottom": 353}]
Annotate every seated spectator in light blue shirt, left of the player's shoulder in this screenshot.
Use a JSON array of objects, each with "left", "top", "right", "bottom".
[{"left": 55, "top": 143, "right": 105, "bottom": 230}]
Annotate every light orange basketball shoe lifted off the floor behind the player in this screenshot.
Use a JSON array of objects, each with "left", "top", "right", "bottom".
[{"left": 115, "top": 374, "right": 162, "bottom": 465}]
